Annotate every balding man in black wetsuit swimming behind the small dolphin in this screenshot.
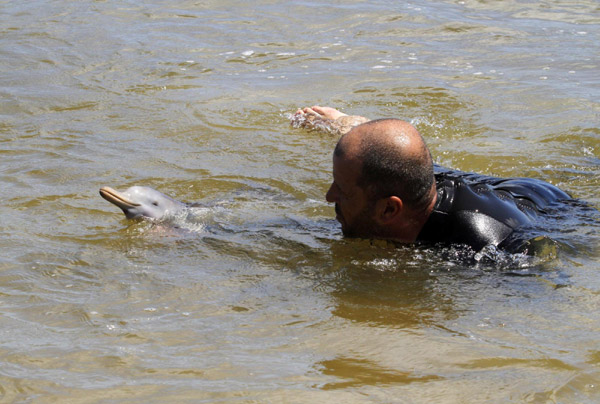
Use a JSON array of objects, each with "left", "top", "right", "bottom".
[{"left": 292, "top": 106, "right": 570, "bottom": 251}]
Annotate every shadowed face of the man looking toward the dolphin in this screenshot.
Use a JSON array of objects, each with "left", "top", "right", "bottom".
[{"left": 325, "top": 156, "right": 376, "bottom": 238}]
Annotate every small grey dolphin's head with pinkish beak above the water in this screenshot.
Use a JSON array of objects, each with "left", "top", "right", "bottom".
[{"left": 100, "top": 186, "right": 185, "bottom": 219}]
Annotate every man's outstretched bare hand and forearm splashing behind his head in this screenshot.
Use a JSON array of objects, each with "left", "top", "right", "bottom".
[{"left": 291, "top": 105, "right": 369, "bottom": 136}]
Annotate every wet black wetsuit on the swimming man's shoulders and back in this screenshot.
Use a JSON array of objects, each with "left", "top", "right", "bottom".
[{"left": 417, "top": 166, "right": 571, "bottom": 250}]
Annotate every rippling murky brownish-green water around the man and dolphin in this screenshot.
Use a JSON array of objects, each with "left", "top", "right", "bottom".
[{"left": 0, "top": 0, "right": 600, "bottom": 403}]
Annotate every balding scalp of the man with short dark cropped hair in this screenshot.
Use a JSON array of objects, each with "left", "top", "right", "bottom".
[{"left": 334, "top": 119, "right": 434, "bottom": 210}]
